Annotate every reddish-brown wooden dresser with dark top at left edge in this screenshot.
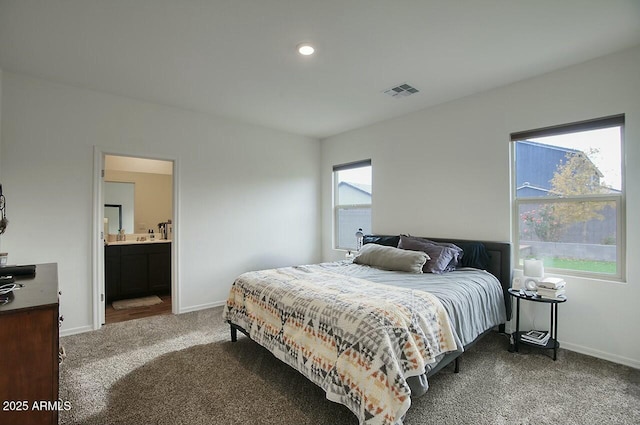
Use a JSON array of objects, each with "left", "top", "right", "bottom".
[{"left": 0, "top": 264, "right": 59, "bottom": 425}]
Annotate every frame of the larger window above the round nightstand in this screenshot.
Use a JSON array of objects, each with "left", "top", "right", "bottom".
[{"left": 509, "top": 114, "right": 626, "bottom": 282}]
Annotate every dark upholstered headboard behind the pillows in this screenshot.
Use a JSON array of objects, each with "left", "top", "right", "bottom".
[{"left": 365, "top": 235, "right": 512, "bottom": 320}]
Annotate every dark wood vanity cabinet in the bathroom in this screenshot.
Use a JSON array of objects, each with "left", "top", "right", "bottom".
[{"left": 105, "top": 242, "right": 171, "bottom": 302}]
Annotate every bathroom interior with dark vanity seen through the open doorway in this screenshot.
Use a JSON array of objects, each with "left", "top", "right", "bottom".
[{"left": 102, "top": 155, "right": 173, "bottom": 324}]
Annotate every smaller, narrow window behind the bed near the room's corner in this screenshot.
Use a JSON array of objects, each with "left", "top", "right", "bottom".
[{"left": 333, "top": 160, "right": 372, "bottom": 250}]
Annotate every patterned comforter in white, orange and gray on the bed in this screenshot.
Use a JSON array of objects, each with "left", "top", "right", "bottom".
[{"left": 223, "top": 265, "right": 458, "bottom": 425}]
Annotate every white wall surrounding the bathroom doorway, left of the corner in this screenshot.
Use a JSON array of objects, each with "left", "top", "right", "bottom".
[{"left": 0, "top": 72, "right": 320, "bottom": 333}]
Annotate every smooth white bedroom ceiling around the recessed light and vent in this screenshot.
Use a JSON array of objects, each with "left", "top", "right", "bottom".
[{"left": 0, "top": 0, "right": 640, "bottom": 138}]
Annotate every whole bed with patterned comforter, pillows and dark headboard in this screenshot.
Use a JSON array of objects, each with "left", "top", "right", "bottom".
[{"left": 223, "top": 235, "right": 511, "bottom": 425}]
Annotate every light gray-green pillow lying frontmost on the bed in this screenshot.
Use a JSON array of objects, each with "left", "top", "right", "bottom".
[{"left": 353, "top": 244, "right": 429, "bottom": 273}]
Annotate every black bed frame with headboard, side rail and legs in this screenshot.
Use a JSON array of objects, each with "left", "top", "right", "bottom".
[{"left": 227, "top": 235, "right": 512, "bottom": 378}]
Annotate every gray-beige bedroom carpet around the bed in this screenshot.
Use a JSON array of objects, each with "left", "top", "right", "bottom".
[{"left": 60, "top": 308, "right": 640, "bottom": 425}]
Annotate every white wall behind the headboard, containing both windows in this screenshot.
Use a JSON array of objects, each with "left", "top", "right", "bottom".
[{"left": 321, "top": 47, "right": 640, "bottom": 368}]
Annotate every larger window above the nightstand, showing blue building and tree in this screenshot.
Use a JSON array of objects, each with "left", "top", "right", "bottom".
[{"left": 511, "top": 115, "right": 625, "bottom": 280}]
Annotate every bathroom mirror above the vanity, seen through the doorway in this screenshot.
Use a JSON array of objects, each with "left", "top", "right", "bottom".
[{"left": 104, "top": 182, "right": 135, "bottom": 234}]
